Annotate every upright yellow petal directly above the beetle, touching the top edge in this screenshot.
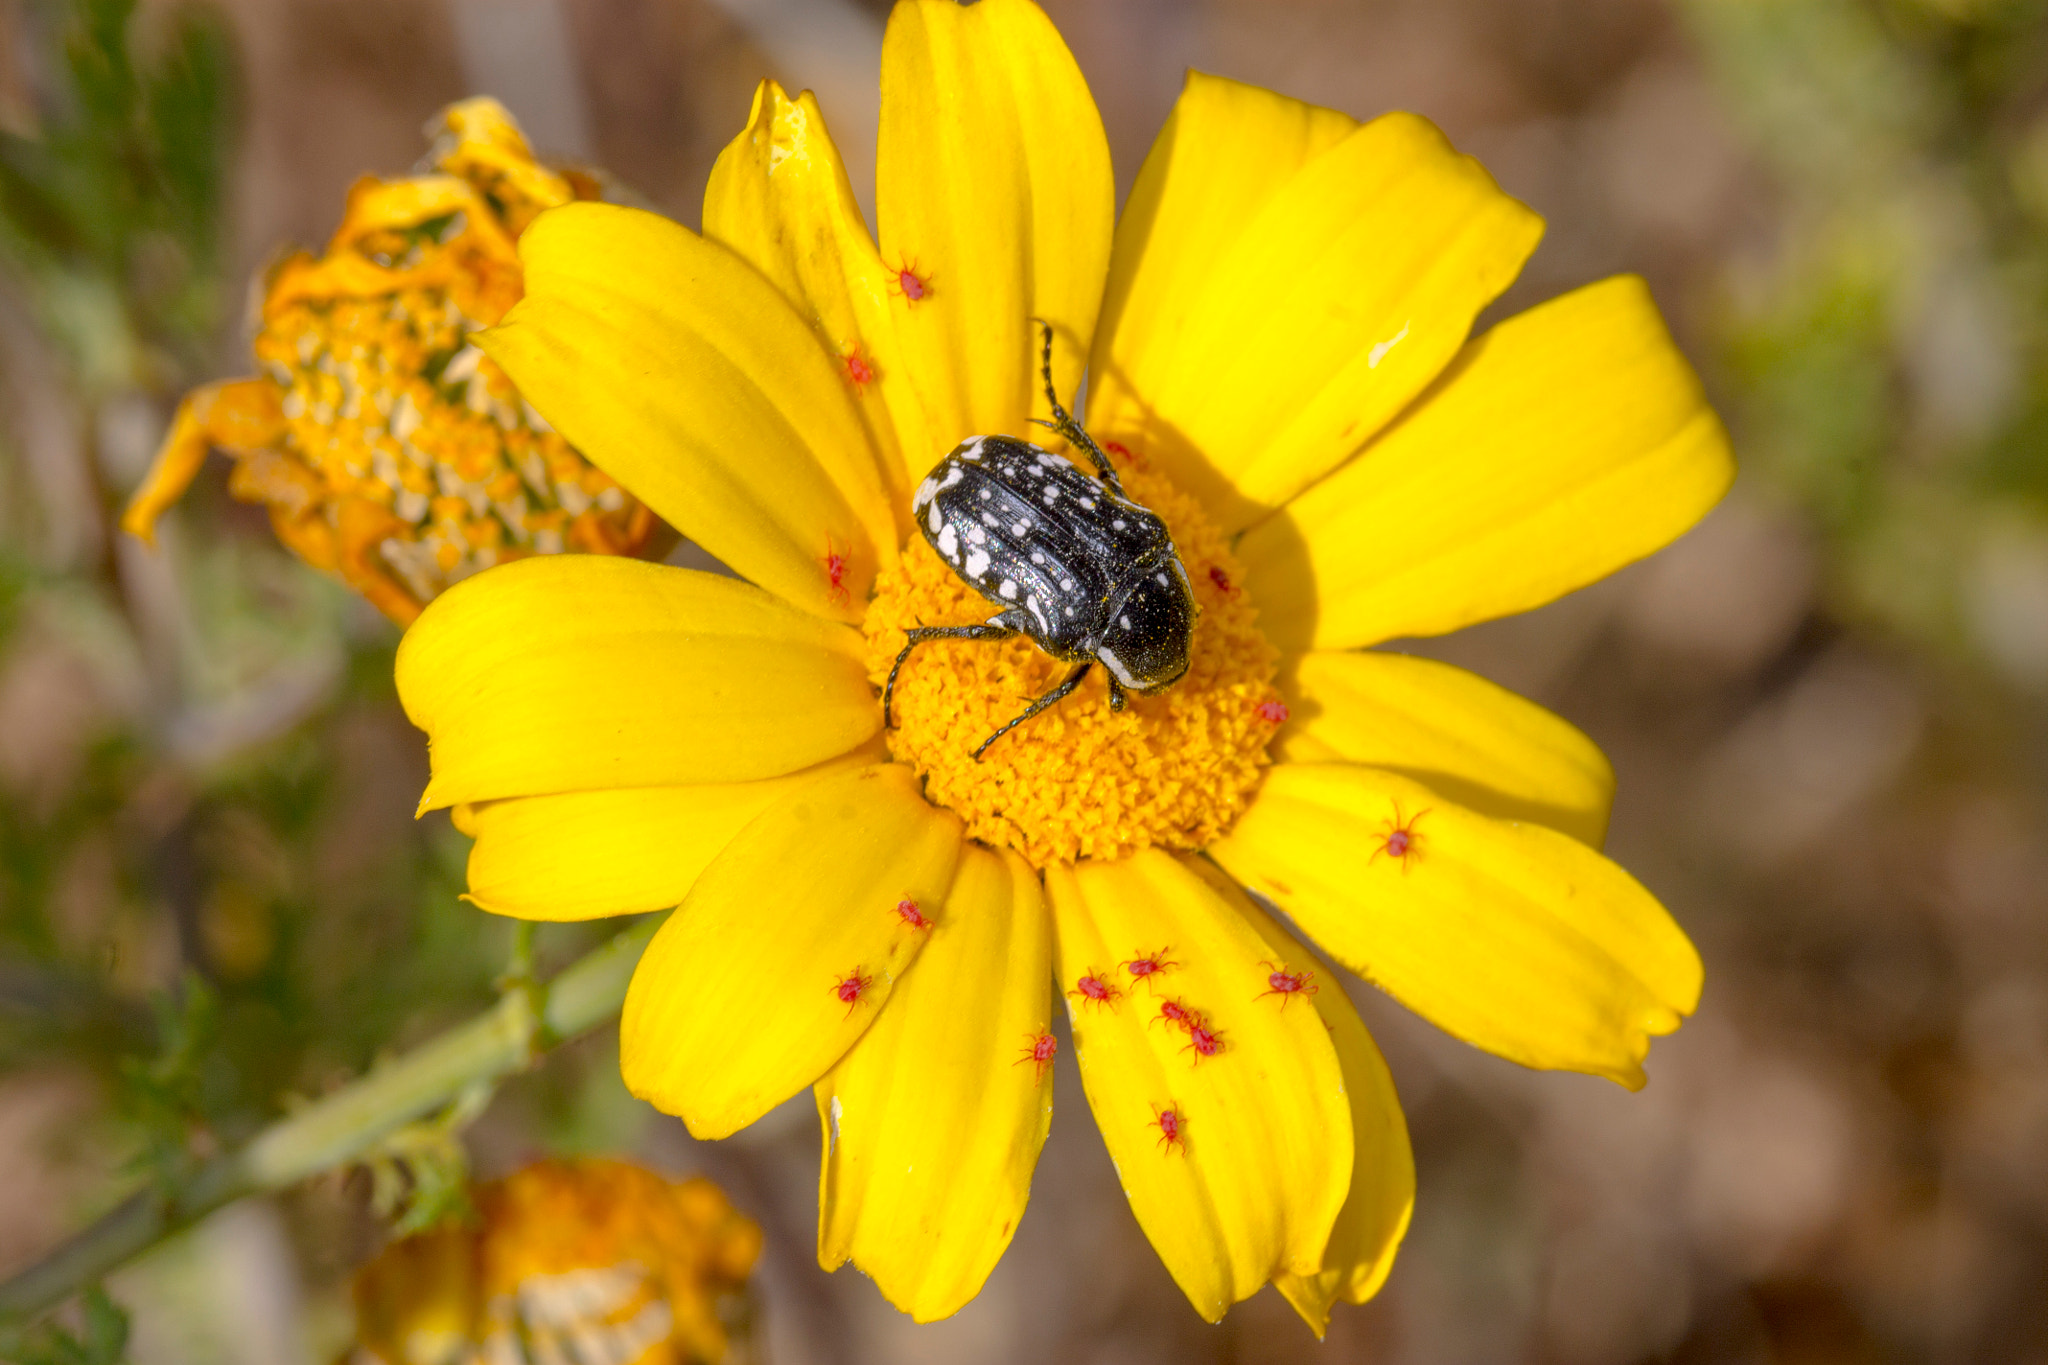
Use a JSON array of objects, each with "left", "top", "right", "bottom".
[{"left": 874, "top": 0, "right": 1114, "bottom": 466}]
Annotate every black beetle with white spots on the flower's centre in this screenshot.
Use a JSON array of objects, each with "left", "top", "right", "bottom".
[{"left": 883, "top": 321, "right": 1196, "bottom": 761}]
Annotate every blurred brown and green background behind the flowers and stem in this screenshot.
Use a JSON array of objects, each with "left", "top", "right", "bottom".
[{"left": 0, "top": 0, "right": 2048, "bottom": 1365}]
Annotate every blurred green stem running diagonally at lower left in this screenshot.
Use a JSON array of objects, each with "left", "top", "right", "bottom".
[{"left": 0, "top": 915, "right": 659, "bottom": 1314}]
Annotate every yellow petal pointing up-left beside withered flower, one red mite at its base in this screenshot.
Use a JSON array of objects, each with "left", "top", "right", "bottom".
[{"left": 477, "top": 203, "right": 897, "bottom": 620}]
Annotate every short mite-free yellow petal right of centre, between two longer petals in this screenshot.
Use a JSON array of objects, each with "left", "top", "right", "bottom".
[{"left": 1274, "top": 653, "right": 1614, "bottom": 849}]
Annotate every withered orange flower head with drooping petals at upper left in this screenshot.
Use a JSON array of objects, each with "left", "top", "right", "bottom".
[{"left": 123, "top": 100, "right": 653, "bottom": 624}]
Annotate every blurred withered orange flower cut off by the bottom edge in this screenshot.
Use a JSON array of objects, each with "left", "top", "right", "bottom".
[{"left": 350, "top": 1160, "right": 762, "bottom": 1365}]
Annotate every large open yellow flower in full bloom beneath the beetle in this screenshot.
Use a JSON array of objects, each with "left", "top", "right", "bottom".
[{"left": 397, "top": 0, "right": 1731, "bottom": 1330}]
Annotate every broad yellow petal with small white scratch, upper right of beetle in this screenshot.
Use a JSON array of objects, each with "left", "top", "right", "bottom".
[{"left": 1087, "top": 76, "right": 1542, "bottom": 530}]
